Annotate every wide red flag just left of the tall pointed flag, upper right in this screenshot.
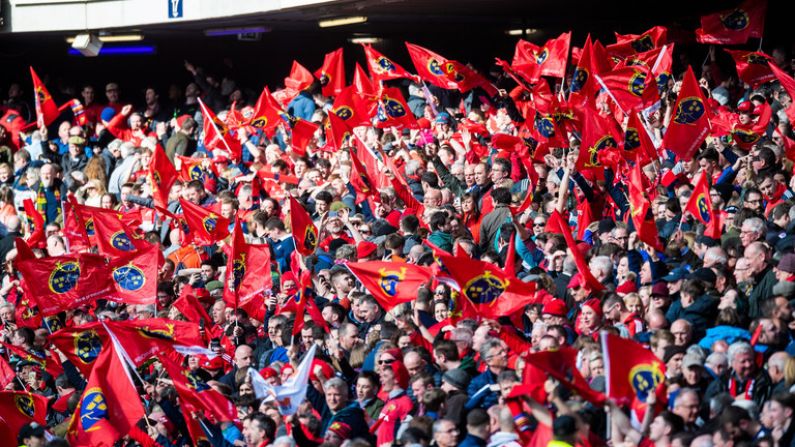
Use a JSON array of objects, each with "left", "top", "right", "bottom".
[{"left": 597, "top": 65, "right": 660, "bottom": 114}]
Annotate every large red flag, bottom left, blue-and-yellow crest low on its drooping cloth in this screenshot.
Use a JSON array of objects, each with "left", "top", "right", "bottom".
[{"left": 67, "top": 344, "right": 145, "bottom": 447}]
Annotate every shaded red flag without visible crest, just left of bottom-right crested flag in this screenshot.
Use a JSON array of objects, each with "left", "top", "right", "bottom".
[{"left": 522, "top": 346, "right": 606, "bottom": 406}]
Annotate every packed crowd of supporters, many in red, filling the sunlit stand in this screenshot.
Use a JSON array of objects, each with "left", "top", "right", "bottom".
[{"left": 0, "top": 11, "right": 795, "bottom": 447}]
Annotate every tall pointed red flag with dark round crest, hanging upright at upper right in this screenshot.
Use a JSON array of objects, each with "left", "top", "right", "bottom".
[{"left": 663, "top": 66, "right": 709, "bottom": 160}]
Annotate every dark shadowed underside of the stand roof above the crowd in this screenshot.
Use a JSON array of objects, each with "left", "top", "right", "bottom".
[{"left": 0, "top": 0, "right": 793, "bottom": 106}]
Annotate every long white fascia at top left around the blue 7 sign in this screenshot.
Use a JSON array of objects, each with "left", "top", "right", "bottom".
[{"left": 5, "top": 0, "right": 336, "bottom": 33}]
